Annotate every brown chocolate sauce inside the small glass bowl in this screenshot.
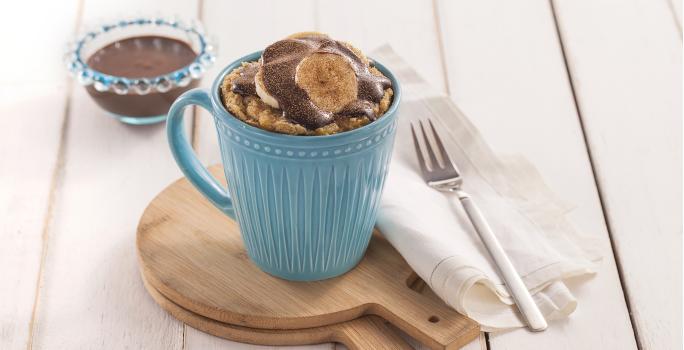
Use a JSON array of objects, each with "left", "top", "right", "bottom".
[{"left": 86, "top": 36, "right": 199, "bottom": 117}]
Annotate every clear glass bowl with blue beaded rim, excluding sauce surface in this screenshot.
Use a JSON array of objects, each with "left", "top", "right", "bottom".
[{"left": 65, "top": 17, "right": 216, "bottom": 125}]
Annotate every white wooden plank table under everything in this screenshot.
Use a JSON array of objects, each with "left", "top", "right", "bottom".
[{"left": 0, "top": 0, "right": 682, "bottom": 350}]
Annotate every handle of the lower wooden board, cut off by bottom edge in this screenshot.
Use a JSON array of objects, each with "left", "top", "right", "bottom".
[{"left": 333, "top": 315, "right": 413, "bottom": 350}]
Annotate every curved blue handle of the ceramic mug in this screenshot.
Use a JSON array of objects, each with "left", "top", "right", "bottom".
[{"left": 166, "top": 88, "right": 235, "bottom": 218}]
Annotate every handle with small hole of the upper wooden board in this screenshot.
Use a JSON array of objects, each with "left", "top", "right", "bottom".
[{"left": 369, "top": 287, "right": 480, "bottom": 349}]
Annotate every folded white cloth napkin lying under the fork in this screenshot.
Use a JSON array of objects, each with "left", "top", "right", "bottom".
[{"left": 372, "top": 46, "right": 601, "bottom": 331}]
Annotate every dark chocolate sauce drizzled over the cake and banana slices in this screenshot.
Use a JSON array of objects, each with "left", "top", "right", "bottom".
[{"left": 232, "top": 35, "right": 392, "bottom": 130}]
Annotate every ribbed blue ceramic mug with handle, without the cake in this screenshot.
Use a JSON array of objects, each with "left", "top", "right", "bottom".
[{"left": 167, "top": 52, "right": 401, "bottom": 281}]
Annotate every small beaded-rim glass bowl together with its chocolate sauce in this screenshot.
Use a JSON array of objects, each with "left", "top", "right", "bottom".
[{"left": 66, "top": 18, "right": 216, "bottom": 125}]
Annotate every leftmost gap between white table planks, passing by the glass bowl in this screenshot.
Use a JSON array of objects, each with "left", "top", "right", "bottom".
[{"left": 26, "top": 0, "right": 84, "bottom": 350}]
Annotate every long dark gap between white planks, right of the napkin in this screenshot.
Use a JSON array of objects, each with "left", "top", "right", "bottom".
[{"left": 549, "top": 0, "right": 643, "bottom": 349}]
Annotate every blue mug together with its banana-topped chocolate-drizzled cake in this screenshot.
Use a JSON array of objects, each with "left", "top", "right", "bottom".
[{"left": 167, "top": 32, "right": 402, "bottom": 281}]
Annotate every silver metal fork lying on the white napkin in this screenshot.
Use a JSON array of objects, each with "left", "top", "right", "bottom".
[{"left": 411, "top": 119, "right": 547, "bottom": 332}]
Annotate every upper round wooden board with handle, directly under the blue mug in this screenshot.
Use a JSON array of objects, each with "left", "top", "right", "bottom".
[{"left": 132, "top": 167, "right": 479, "bottom": 349}]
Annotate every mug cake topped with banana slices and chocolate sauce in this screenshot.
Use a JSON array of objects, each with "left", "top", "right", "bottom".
[{"left": 221, "top": 32, "right": 393, "bottom": 135}]
